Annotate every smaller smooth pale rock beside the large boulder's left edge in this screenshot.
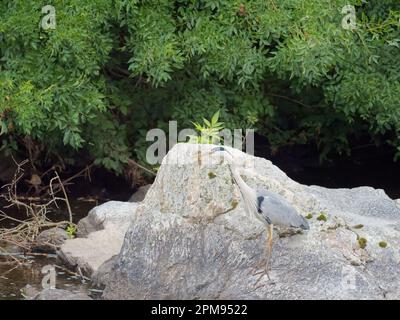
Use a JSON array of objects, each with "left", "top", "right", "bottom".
[{"left": 58, "top": 201, "right": 138, "bottom": 276}]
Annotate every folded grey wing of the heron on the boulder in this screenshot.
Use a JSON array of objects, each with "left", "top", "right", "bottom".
[{"left": 257, "top": 189, "right": 309, "bottom": 229}]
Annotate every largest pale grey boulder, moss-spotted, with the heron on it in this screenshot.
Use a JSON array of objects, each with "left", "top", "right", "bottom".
[{"left": 103, "top": 144, "right": 400, "bottom": 299}]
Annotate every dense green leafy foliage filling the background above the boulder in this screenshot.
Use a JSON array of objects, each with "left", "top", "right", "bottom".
[{"left": 0, "top": 0, "right": 400, "bottom": 172}]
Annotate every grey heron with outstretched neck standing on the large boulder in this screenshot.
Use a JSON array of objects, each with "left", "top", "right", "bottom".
[{"left": 210, "top": 147, "right": 310, "bottom": 282}]
